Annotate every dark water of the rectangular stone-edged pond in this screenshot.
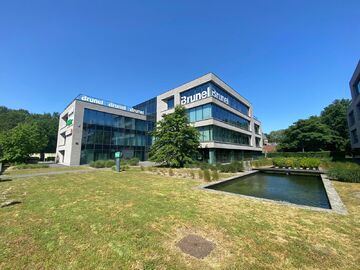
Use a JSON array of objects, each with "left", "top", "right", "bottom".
[{"left": 207, "top": 172, "right": 331, "bottom": 209}]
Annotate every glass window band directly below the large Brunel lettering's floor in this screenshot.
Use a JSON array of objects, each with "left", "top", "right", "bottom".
[{"left": 187, "top": 103, "right": 250, "bottom": 130}]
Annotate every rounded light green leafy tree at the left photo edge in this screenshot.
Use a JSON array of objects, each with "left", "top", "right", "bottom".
[{"left": 0, "top": 121, "right": 48, "bottom": 162}]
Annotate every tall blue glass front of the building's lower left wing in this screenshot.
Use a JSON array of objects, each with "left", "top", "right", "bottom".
[{"left": 80, "top": 109, "right": 151, "bottom": 164}]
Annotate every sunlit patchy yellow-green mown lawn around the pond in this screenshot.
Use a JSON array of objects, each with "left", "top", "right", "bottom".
[{"left": 0, "top": 170, "right": 360, "bottom": 269}]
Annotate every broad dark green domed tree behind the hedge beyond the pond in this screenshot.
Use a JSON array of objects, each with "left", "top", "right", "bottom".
[{"left": 280, "top": 116, "right": 339, "bottom": 152}]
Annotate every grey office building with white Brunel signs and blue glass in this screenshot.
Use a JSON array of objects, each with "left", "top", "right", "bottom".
[{"left": 56, "top": 73, "right": 262, "bottom": 165}]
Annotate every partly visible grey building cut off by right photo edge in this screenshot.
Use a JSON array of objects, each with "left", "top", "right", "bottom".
[{"left": 348, "top": 61, "right": 360, "bottom": 150}]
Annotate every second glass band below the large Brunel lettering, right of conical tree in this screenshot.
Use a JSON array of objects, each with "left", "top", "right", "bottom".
[{"left": 197, "top": 126, "right": 250, "bottom": 146}]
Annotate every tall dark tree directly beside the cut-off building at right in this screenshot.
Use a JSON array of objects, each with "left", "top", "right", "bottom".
[{"left": 320, "top": 99, "right": 350, "bottom": 151}]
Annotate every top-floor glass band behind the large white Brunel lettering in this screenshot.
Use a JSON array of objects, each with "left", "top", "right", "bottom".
[{"left": 180, "top": 82, "right": 249, "bottom": 115}]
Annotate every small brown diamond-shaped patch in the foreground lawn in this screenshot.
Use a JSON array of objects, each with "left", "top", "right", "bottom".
[{"left": 176, "top": 234, "right": 215, "bottom": 259}]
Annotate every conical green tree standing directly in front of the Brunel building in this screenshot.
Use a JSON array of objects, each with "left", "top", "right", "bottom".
[{"left": 149, "top": 105, "right": 200, "bottom": 167}]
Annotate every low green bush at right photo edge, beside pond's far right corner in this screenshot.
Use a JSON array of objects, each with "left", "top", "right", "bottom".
[{"left": 326, "top": 162, "right": 360, "bottom": 183}]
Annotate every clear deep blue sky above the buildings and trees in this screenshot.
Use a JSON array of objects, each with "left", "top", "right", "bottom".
[{"left": 0, "top": 0, "right": 360, "bottom": 132}]
